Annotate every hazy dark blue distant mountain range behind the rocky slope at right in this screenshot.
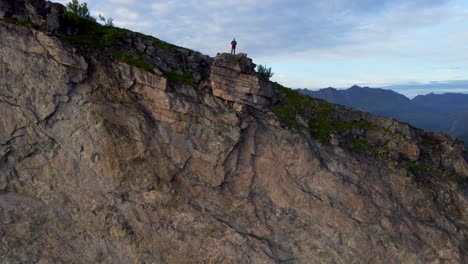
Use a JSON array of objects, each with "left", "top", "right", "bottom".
[{"left": 297, "top": 85, "right": 468, "bottom": 145}]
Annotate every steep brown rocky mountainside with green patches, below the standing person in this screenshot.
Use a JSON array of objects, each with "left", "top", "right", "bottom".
[{"left": 0, "top": 0, "right": 468, "bottom": 263}]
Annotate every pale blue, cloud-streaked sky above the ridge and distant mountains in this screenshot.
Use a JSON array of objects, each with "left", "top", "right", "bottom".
[{"left": 57, "top": 0, "right": 468, "bottom": 97}]
